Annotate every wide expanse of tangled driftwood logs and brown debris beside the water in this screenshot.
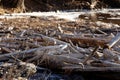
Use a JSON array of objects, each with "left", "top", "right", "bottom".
[{"left": 0, "top": 10, "right": 120, "bottom": 79}]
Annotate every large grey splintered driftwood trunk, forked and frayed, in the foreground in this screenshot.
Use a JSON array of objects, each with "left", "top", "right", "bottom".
[{"left": 0, "top": 46, "right": 84, "bottom": 68}]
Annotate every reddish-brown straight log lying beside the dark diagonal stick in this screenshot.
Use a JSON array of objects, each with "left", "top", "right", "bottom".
[{"left": 59, "top": 35, "right": 110, "bottom": 47}]
